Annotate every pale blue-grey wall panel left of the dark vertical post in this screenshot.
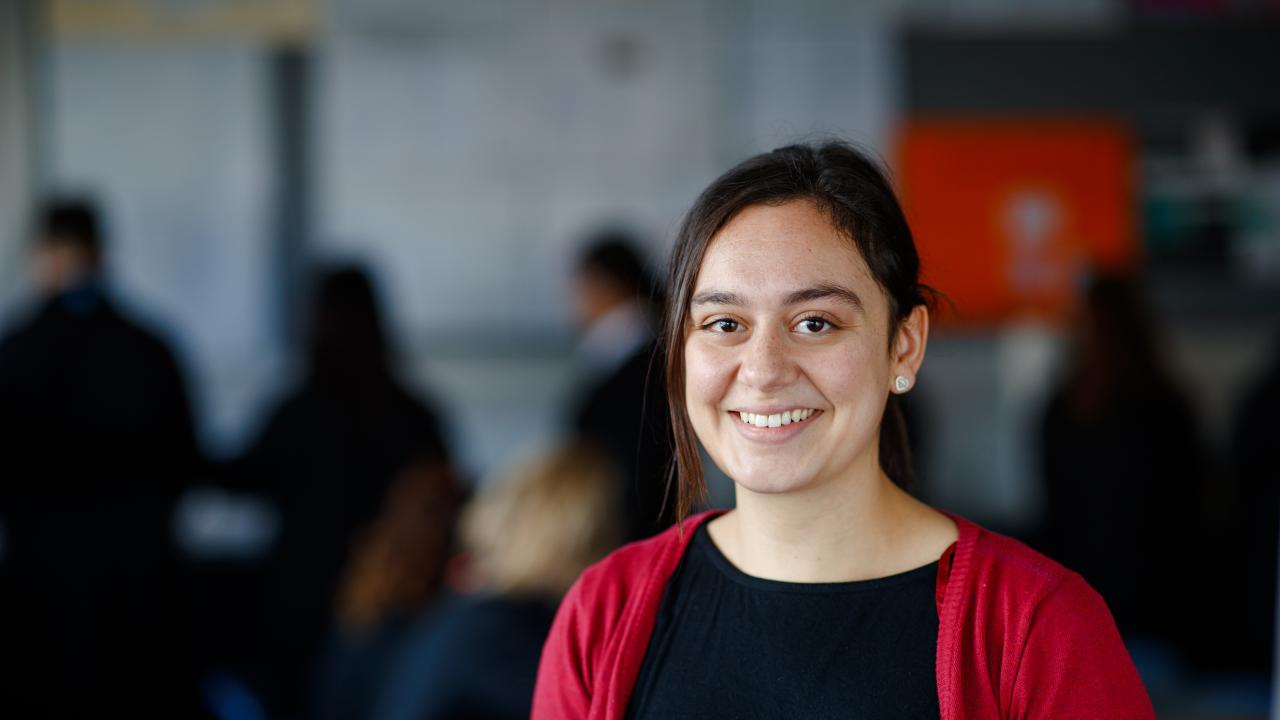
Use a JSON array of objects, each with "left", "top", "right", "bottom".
[{"left": 42, "top": 41, "right": 279, "bottom": 450}]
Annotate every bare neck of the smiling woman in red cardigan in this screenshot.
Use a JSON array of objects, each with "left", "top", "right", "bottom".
[{"left": 708, "top": 465, "right": 956, "bottom": 583}]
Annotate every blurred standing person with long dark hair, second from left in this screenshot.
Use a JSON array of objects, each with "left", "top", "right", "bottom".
[{"left": 236, "top": 266, "right": 447, "bottom": 717}]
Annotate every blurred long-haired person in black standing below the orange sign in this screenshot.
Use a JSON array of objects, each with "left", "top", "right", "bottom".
[{"left": 1042, "top": 275, "right": 1204, "bottom": 650}]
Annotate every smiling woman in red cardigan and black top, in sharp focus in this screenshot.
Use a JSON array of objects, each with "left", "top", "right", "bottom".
[{"left": 534, "top": 143, "right": 1155, "bottom": 720}]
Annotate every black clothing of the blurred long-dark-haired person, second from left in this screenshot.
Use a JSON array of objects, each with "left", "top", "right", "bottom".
[{"left": 229, "top": 356, "right": 447, "bottom": 717}]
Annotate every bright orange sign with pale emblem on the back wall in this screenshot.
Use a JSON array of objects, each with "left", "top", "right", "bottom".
[{"left": 899, "top": 120, "right": 1138, "bottom": 324}]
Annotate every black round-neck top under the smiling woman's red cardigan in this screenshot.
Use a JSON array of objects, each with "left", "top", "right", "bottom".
[{"left": 627, "top": 525, "right": 940, "bottom": 720}]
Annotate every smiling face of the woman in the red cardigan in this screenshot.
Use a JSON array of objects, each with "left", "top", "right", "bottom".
[{"left": 685, "top": 201, "right": 927, "bottom": 493}]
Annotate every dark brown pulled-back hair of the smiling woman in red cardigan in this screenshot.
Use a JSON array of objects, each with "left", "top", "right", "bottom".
[{"left": 662, "top": 142, "right": 933, "bottom": 519}]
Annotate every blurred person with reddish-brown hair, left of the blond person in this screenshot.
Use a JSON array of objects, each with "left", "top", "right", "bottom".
[{"left": 310, "top": 461, "right": 462, "bottom": 720}]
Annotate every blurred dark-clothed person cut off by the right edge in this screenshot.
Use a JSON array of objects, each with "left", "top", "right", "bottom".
[{"left": 1224, "top": 327, "right": 1280, "bottom": 678}]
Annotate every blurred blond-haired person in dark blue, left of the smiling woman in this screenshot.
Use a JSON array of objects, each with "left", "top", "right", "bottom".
[{"left": 372, "top": 442, "right": 622, "bottom": 720}]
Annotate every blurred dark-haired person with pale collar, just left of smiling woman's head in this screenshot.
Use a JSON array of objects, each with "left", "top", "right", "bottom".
[{"left": 572, "top": 231, "right": 673, "bottom": 539}]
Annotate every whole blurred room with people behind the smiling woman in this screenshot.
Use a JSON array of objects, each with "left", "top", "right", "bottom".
[{"left": 0, "top": 0, "right": 1280, "bottom": 719}]
